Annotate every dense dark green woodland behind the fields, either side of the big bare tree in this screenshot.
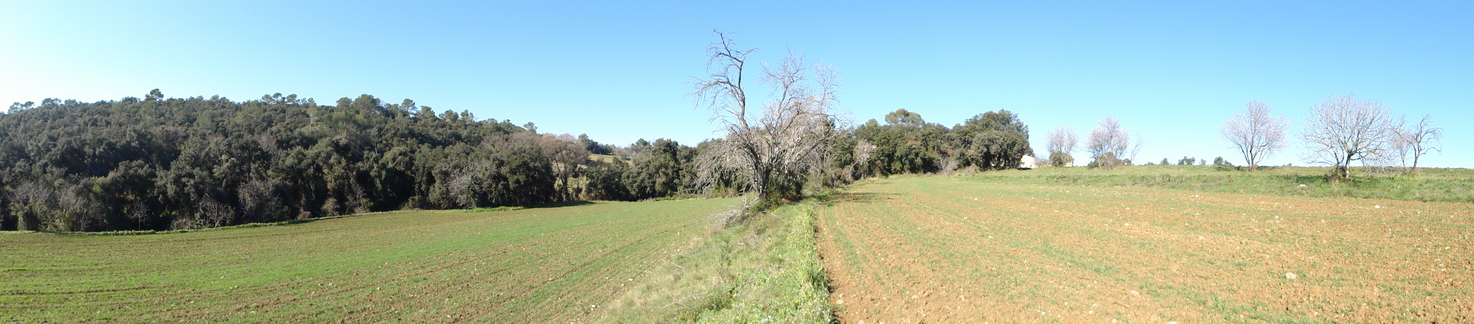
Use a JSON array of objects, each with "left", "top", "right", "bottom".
[{"left": 0, "top": 90, "right": 1033, "bottom": 231}]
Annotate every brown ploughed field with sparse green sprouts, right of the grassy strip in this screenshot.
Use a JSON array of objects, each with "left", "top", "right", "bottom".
[{"left": 817, "top": 177, "right": 1474, "bottom": 324}]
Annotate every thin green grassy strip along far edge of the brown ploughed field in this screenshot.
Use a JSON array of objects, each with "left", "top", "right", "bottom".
[{"left": 961, "top": 165, "right": 1474, "bottom": 202}]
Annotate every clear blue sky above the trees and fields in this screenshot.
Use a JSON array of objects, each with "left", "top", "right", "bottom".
[{"left": 0, "top": 0, "right": 1474, "bottom": 168}]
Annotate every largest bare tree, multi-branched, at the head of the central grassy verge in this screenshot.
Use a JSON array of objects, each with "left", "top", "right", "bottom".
[{"left": 694, "top": 31, "right": 839, "bottom": 208}]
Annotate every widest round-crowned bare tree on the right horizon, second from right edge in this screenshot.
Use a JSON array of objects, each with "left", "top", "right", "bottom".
[{"left": 1302, "top": 94, "right": 1396, "bottom": 180}]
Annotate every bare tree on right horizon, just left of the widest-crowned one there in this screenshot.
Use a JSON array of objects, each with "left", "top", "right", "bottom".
[{"left": 1218, "top": 100, "right": 1290, "bottom": 171}]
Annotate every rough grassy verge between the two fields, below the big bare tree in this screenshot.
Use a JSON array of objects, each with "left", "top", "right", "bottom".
[{"left": 601, "top": 199, "right": 833, "bottom": 323}]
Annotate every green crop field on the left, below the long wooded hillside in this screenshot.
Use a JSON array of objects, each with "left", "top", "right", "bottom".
[{"left": 0, "top": 199, "right": 736, "bottom": 323}]
